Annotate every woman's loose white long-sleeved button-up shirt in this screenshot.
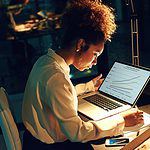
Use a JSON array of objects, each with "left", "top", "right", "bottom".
[{"left": 22, "top": 49, "right": 124, "bottom": 143}]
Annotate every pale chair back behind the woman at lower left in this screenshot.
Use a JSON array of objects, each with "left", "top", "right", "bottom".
[{"left": 0, "top": 87, "right": 22, "bottom": 150}]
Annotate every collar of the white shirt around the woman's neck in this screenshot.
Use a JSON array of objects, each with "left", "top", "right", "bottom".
[{"left": 47, "top": 48, "right": 70, "bottom": 75}]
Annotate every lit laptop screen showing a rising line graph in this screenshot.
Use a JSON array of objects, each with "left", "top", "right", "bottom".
[{"left": 99, "top": 62, "right": 150, "bottom": 104}]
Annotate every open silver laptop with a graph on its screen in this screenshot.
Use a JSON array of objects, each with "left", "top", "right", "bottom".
[{"left": 78, "top": 61, "right": 150, "bottom": 120}]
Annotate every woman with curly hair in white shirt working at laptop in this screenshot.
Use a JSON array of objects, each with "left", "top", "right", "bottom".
[{"left": 22, "top": 0, "right": 143, "bottom": 150}]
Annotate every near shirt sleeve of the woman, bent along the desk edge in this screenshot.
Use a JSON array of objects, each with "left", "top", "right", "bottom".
[{"left": 46, "top": 73, "right": 124, "bottom": 142}]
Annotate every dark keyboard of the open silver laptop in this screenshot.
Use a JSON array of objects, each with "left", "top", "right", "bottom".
[{"left": 83, "top": 94, "right": 122, "bottom": 111}]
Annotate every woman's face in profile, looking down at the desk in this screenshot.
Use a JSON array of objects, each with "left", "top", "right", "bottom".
[{"left": 73, "top": 42, "right": 104, "bottom": 71}]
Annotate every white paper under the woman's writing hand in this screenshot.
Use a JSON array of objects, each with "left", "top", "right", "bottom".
[{"left": 124, "top": 112, "right": 150, "bottom": 134}]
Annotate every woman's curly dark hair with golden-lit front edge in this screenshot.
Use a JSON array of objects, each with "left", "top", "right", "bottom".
[{"left": 61, "top": 0, "right": 116, "bottom": 47}]
